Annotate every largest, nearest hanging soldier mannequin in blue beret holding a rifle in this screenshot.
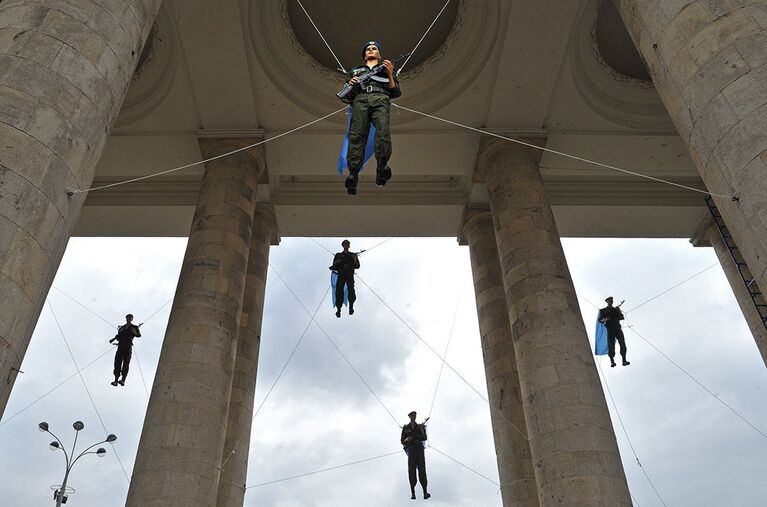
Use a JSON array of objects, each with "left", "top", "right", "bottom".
[{"left": 346, "top": 41, "right": 402, "bottom": 195}]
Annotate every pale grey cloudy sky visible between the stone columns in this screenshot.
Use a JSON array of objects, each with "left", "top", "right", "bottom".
[{"left": 0, "top": 238, "right": 767, "bottom": 507}]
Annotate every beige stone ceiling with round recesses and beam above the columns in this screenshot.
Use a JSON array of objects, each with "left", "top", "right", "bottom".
[{"left": 75, "top": 0, "right": 705, "bottom": 237}]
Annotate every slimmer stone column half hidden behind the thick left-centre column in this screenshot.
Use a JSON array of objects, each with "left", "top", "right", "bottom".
[{"left": 216, "top": 204, "right": 277, "bottom": 507}]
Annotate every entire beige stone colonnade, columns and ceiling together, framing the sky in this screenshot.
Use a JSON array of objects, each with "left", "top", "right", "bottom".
[{"left": 0, "top": 0, "right": 767, "bottom": 507}]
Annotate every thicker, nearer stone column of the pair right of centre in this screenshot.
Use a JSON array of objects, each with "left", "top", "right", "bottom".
[{"left": 478, "top": 143, "right": 631, "bottom": 506}]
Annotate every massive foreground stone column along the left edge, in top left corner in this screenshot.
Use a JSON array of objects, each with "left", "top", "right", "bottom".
[{"left": 0, "top": 0, "right": 161, "bottom": 414}]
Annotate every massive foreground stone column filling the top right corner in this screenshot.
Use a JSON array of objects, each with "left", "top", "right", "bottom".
[{"left": 614, "top": 0, "right": 767, "bottom": 302}]
